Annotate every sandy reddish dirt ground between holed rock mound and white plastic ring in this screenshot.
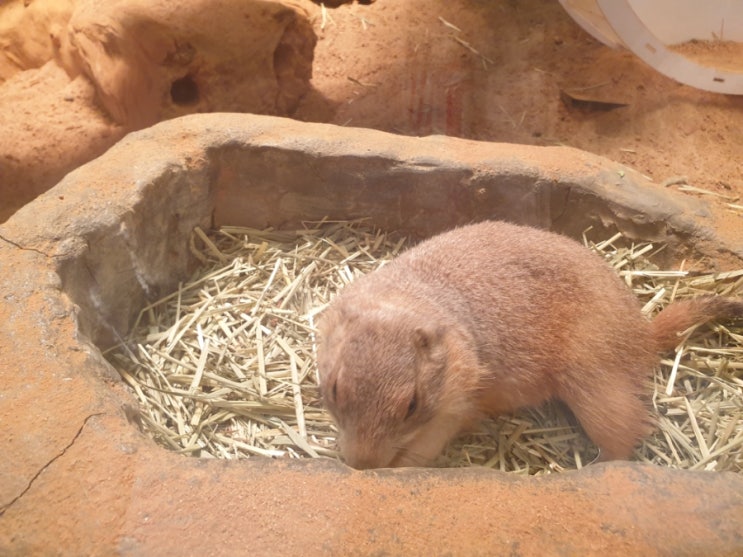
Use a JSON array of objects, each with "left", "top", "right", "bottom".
[{"left": 295, "top": 0, "right": 743, "bottom": 234}]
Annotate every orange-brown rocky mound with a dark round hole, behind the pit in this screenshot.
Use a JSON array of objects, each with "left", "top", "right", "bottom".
[{"left": 0, "top": 0, "right": 316, "bottom": 222}]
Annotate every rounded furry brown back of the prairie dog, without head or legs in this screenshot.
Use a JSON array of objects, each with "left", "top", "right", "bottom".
[{"left": 374, "top": 222, "right": 654, "bottom": 396}]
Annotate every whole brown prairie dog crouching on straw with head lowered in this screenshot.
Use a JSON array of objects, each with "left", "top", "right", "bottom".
[{"left": 318, "top": 222, "right": 743, "bottom": 468}]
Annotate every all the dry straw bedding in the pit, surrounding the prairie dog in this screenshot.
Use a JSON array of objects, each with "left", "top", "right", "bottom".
[{"left": 110, "top": 222, "right": 743, "bottom": 474}]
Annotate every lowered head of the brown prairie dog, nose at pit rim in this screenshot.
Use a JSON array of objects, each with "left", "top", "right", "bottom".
[{"left": 318, "top": 297, "right": 480, "bottom": 468}]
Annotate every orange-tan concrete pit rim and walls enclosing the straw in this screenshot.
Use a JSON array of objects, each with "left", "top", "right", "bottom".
[{"left": 0, "top": 114, "right": 743, "bottom": 555}]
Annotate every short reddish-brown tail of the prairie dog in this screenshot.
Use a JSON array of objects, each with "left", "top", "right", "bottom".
[{"left": 651, "top": 296, "right": 743, "bottom": 352}]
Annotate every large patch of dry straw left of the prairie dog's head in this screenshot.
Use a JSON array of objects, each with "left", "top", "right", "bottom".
[{"left": 111, "top": 222, "right": 403, "bottom": 458}]
